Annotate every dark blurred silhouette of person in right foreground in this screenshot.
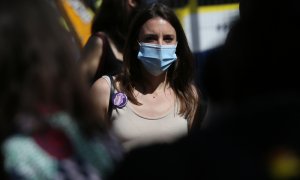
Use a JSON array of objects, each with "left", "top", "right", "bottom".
[{"left": 111, "top": 0, "right": 300, "bottom": 180}]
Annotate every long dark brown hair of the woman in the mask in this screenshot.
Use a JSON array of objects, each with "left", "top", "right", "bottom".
[{"left": 118, "top": 3, "right": 198, "bottom": 120}]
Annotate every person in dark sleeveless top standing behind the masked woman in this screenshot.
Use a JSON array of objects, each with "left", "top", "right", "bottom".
[{"left": 80, "top": 0, "right": 152, "bottom": 84}]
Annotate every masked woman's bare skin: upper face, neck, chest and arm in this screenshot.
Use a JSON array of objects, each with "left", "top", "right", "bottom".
[{"left": 91, "top": 17, "right": 177, "bottom": 123}]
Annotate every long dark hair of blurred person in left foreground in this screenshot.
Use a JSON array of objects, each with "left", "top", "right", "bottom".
[{"left": 0, "top": 0, "right": 105, "bottom": 140}]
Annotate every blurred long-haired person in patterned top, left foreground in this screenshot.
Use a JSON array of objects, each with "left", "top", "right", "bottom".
[{"left": 0, "top": 0, "right": 123, "bottom": 180}]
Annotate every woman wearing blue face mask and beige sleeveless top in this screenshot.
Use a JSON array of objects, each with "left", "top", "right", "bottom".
[{"left": 91, "top": 3, "right": 200, "bottom": 151}]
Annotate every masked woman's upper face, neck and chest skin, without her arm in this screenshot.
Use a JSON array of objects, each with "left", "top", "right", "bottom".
[{"left": 133, "top": 17, "right": 177, "bottom": 118}]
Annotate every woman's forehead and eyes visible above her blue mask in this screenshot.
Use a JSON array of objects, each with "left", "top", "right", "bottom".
[{"left": 138, "top": 17, "right": 177, "bottom": 45}]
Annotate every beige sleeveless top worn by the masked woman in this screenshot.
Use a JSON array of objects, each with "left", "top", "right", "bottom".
[{"left": 103, "top": 76, "right": 188, "bottom": 151}]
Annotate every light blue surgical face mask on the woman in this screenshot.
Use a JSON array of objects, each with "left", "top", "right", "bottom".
[{"left": 137, "top": 43, "right": 177, "bottom": 76}]
